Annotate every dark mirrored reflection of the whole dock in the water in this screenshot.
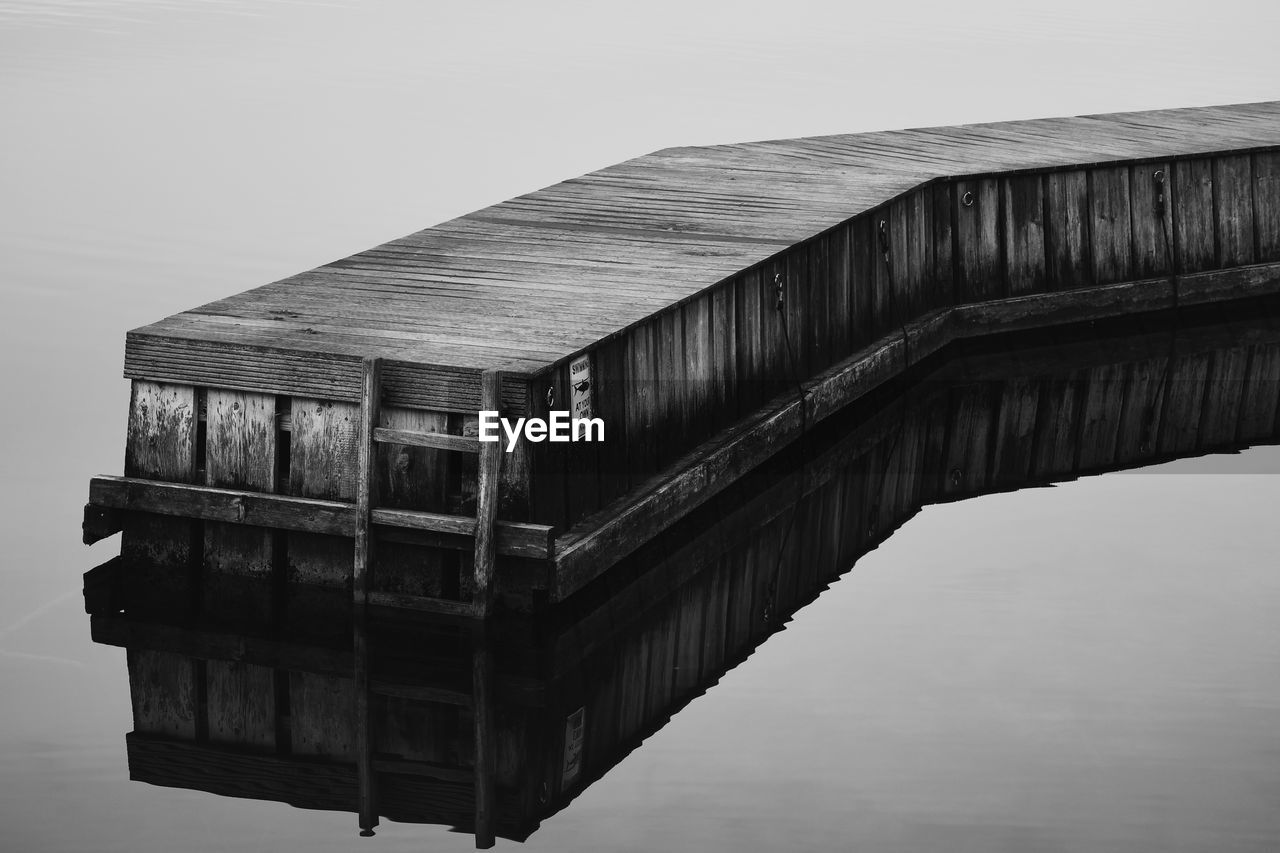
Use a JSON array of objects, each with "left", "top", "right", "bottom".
[{"left": 86, "top": 298, "right": 1280, "bottom": 845}]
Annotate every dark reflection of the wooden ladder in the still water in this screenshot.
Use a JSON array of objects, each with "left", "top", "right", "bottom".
[{"left": 353, "top": 603, "right": 497, "bottom": 849}]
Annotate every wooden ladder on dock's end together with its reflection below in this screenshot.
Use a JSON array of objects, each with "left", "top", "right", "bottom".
[{"left": 352, "top": 359, "right": 502, "bottom": 848}]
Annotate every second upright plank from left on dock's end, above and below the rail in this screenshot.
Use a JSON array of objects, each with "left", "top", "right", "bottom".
[{"left": 205, "top": 389, "right": 276, "bottom": 624}]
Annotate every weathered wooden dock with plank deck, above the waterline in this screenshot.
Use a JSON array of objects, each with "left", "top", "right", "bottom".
[{"left": 86, "top": 102, "right": 1280, "bottom": 612}]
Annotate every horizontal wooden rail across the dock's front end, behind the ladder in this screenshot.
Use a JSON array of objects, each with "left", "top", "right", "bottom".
[{"left": 88, "top": 475, "right": 553, "bottom": 560}]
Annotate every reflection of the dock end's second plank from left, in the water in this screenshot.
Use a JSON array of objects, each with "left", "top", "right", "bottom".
[{"left": 205, "top": 661, "right": 275, "bottom": 752}]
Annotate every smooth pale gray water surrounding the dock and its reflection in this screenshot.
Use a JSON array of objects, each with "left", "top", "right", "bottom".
[{"left": 0, "top": 0, "right": 1280, "bottom": 852}]
